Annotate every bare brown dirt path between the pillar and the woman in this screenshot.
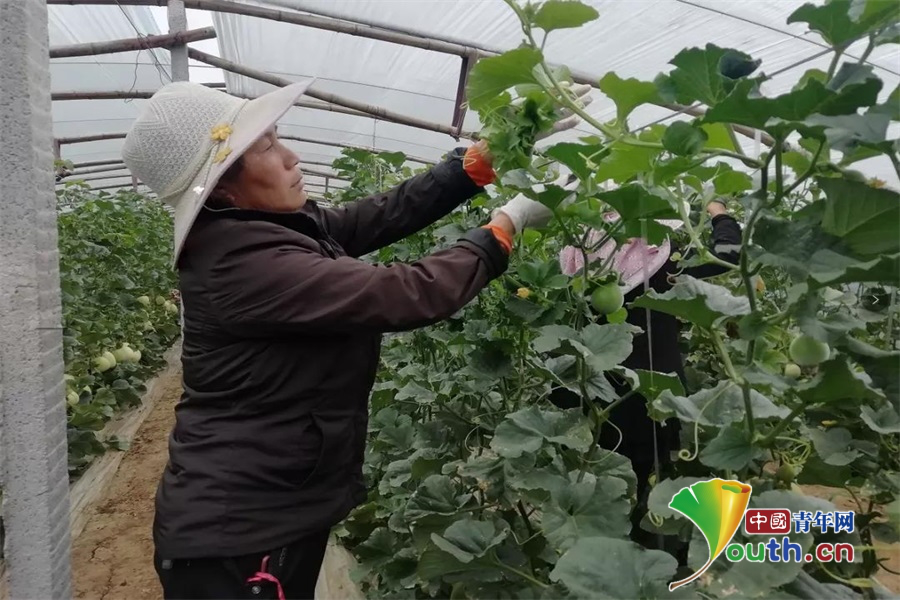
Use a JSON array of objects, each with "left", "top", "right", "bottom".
[{"left": 72, "top": 373, "right": 181, "bottom": 600}]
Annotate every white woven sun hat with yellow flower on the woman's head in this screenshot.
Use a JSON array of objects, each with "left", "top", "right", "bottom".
[{"left": 122, "top": 80, "right": 312, "bottom": 261}]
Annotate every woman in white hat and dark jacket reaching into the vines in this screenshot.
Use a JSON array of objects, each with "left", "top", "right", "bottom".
[{"left": 123, "top": 83, "right": 575, "bottom": 598}]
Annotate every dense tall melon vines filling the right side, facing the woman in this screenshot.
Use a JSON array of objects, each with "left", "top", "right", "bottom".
[{"left": 340, "top": 0, "right": 900, "bottom": 598}]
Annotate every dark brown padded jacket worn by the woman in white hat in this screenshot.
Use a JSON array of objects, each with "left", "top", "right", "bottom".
[{"left": 153, "top": 150, "right": 508, "bottom": 559}]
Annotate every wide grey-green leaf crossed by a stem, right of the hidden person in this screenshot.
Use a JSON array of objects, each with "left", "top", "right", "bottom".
[{"left": 651, "top": 381, "right": 790, "bottom": 427}]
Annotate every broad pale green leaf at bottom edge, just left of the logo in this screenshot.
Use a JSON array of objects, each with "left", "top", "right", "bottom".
[{"left": 550, "top": 537, "right": 678, "bottom": 600}]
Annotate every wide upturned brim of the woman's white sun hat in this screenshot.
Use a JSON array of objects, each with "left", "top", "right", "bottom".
[{"left": 173, "top": 79, "right": 314, "bottom": 263}]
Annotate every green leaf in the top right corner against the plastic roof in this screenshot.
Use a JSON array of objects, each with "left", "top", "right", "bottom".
[{"left": 787, "top": 0, "right": 896, "bottom": 47}]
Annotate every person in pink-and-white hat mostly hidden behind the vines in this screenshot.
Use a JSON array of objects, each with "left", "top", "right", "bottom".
[{"left": 550, "top": 200, "right": 741, "bottom": 546}]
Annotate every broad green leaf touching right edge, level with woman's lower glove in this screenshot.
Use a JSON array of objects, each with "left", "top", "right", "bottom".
[{"left": 816, "top": 178, "right": 900, "bottom": 255}]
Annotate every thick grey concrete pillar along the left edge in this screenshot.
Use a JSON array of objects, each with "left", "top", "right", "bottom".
[{"left": 0, "top": 0, "right": 72, "bottom": 599}]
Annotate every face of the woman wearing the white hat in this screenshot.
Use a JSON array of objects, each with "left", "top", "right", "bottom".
[{"left": 217, "top": 127, "right": 307, "bottom": 212}]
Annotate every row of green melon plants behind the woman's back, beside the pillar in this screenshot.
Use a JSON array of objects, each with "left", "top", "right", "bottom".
[{"left": 57, "top": 184, "right": 181, "bottom": 475}]
